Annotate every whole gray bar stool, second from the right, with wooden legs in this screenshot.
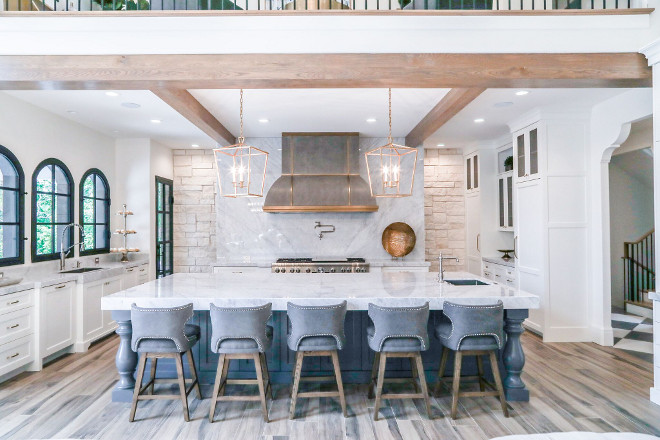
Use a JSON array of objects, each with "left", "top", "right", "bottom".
[{"left": 367, "top": 302, "right": 431, "bottom": 420}]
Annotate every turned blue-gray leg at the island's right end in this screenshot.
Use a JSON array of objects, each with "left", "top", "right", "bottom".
[{"left": 502, "top": 309, "right": 529, "bottom": 402}]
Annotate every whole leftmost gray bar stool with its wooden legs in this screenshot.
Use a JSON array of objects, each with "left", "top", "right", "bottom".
[{"left": 129, "top": 304, "right": 202, "bottom": 422}]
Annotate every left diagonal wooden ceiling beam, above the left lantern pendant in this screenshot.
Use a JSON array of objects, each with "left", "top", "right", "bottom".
[{"left": 151, "top": 88, "right": 236, "bottom": 145}]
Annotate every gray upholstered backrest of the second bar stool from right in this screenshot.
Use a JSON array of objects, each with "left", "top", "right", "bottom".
[{"left": 368, "top": 301, "right": 429, "bottom": 351}]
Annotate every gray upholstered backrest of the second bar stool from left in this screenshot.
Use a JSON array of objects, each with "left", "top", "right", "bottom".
[{"left": 210, "top": 303, "right": 273, "bottom": 353}]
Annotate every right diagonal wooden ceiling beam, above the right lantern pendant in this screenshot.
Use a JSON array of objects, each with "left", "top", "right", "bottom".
[{"left": 406, "top": 88, "right": 486, "bottom": 147}]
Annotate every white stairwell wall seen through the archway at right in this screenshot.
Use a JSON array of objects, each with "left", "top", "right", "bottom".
[{"left": 609, "top": 160, "right": 653, "bottom": 307}]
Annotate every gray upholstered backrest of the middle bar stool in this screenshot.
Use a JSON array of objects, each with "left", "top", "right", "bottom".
[{"left": 287, "top": 301, "right": 346, "bottom": 350}]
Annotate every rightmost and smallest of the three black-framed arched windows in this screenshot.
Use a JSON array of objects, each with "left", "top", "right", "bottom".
[{"left": 80, "top": 168, "right": 110, "bottom": 255}]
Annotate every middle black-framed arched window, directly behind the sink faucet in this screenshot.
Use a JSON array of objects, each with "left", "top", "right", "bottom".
[{"left": 32, "top": 159, "right": 74, "bottom": 262}]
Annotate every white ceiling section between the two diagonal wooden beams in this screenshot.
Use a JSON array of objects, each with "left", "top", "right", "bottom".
[{"left": 190, "top": 89, "right": 449, "bottom": 137}]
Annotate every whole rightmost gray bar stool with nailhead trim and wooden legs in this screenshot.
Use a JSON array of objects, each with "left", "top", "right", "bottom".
[{"left": 435, "top": 301, "right": 509, "bottom": 419}]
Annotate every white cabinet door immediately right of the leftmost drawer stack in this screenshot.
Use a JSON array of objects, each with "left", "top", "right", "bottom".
[{"left": 39, "top": 281, "right": 76, "bottom": 358}]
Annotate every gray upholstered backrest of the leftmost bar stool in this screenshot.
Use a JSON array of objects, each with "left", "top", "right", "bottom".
[{"left": 131, "top": 303, "right": 193, "bottom": 352}]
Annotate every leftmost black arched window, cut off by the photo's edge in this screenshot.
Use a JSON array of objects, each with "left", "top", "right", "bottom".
[{"left": 0, "top": 145, "right": 25, "bottom": 266}]
